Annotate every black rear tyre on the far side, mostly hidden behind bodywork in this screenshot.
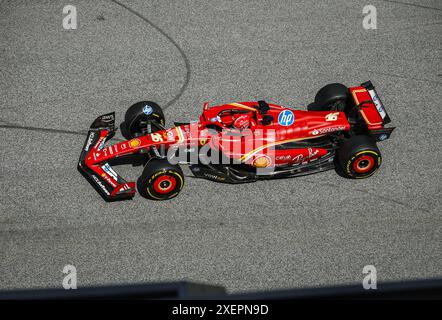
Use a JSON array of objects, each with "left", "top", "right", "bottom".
[{"left": 307, "top": 83, "right": 348, "bottom": 111}]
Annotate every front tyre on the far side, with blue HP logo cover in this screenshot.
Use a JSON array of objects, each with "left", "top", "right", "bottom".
[{"left": 120, "top": 101, "right": 166, "bottom": 140}]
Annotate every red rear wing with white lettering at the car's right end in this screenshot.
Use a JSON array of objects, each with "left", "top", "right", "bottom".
[{"left": 350, "top": 81, "right": 395, "bottom": 141}]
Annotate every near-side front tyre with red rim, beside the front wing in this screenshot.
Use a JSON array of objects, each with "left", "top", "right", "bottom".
[{"left": 137, "top": 159, "right": 184, "bottom": 200}]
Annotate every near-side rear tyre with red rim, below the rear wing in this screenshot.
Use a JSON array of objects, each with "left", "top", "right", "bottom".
[{"left": 337, "top": 135, "right": 382, "bottom": 179}]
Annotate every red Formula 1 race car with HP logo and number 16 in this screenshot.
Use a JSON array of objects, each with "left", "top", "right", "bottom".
[{"left": 78, "top": 81, "right": 394, "bottom": 201}]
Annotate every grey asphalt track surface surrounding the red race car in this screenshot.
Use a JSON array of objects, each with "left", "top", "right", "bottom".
[{"left": 0, "top": 0, "right": 442, "bottom": 292}]
